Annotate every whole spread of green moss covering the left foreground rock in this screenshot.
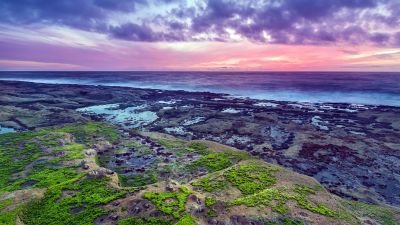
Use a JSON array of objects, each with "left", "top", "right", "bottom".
[{"left": 0, "top": 123, "right": 125, "bottom": 224}]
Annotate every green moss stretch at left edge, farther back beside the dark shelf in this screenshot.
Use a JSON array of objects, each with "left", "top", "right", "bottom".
[{"left": 0, "top": 123, "right": 119, "bottom": 193}]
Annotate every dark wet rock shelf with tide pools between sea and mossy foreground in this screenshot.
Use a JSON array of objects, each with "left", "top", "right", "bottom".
[{"left": 0, "top": 81, "right": 400, "bottom": 206}]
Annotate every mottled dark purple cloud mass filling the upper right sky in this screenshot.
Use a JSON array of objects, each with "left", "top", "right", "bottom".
[{"left": 182, "top": 0, "right": 394, "bottom": 44}]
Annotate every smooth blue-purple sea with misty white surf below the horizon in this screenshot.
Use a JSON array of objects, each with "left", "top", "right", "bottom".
[{"left": 0, "top": 72, "right": 400, "bottom": 106}]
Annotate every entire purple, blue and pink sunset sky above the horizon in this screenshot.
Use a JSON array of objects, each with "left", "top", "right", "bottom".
[{"left": 0, "top": 0, "right": 400, "bottom": 72}]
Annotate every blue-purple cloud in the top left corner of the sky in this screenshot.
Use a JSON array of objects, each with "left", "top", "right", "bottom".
[{"left": 0, "top": 0, "right": 146, "bottom": 30}]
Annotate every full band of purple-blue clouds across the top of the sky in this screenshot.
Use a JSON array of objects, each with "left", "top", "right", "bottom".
[{"left": 0, "top": 0, "right": 400, "bottom": 46}]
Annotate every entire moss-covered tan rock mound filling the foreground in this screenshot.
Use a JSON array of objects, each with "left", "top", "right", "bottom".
[{"left": 0, "top": 122, "right": 400, "bottom": 225}]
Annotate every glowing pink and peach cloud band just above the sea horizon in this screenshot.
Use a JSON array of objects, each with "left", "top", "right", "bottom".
[{"left": 0, "top": 35, "right": 400, "bottom": 71}]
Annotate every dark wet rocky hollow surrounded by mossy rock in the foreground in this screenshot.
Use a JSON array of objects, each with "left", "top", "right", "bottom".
[{"left": 98, "top": 129, "right": 206, "bottom": 186}]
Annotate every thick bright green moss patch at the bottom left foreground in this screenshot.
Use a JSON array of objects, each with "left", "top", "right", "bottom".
[{"left": 21, "top": 175, "right": 125, "bottom": 225}]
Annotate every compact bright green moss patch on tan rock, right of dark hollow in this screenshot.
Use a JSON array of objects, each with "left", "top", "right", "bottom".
[{"left": 224, "top": 164, "right": 277, "bottom": 195}]
